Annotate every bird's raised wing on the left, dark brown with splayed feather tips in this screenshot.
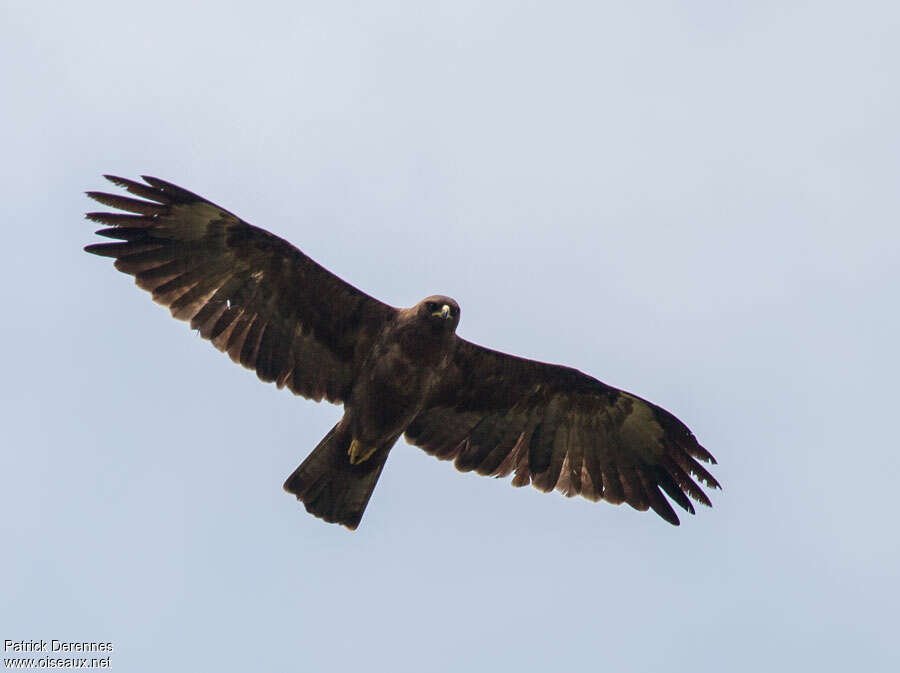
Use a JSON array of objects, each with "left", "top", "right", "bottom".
[{"left": 85, "top": 175, "right": 396, "bottom": 402}]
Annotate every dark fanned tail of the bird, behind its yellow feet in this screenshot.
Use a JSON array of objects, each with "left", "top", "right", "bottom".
[{"left": 284, "top": 422, "right": 390, "bottom": 530}]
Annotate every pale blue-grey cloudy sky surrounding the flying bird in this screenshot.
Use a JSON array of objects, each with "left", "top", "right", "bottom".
[{"left": 0, "top": 0, "right": 900, "bottom": 673}]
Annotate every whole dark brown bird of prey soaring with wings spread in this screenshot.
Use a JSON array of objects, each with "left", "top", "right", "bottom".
[{"left": 85, "top": 175, "right": 719, "bottom": 529}]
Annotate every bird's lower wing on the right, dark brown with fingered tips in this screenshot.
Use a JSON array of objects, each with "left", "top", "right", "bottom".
[{"left": 406, "top": 339, "right": 719, "bottom": 525}]
